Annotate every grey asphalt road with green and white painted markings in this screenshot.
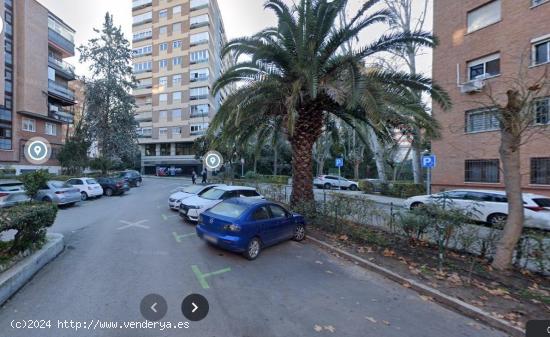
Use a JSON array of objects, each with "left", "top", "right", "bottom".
[{"left": 0, "top": 179, "right": 505, "bottom": 337}]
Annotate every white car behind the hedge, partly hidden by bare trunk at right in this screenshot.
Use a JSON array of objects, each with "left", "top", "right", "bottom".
[{"left": 404, "top": 189, "right": 550, "bottom": 230}]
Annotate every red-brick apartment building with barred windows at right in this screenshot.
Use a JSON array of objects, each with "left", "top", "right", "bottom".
[{"left": 433, "top": 0, "right": 550, "bottom": 195}]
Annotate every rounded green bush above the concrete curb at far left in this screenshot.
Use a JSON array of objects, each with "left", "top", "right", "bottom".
[{"left": 0, "top": 203, "right": 57, "bottom": 255}]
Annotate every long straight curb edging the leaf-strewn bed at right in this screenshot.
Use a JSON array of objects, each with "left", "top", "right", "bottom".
[{"left": 307, "top": 236, "right": 525, "bottom": 337}]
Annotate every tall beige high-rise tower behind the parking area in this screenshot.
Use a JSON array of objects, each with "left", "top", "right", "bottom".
[{"left": 132, "top": 0, "right": 232, "bottom": 175}]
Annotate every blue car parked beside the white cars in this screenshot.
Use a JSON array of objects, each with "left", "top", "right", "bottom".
[{"left": 196, "top": 198, "right": 306, "bottom": 260}]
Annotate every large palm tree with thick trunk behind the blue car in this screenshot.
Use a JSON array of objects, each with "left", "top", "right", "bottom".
[{"left": 211, "top": 0, "right": 449, "bottom": 204}]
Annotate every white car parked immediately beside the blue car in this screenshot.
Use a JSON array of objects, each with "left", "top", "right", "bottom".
[{"left": 179, "top": 186, "right": 263, "bottom": 222}]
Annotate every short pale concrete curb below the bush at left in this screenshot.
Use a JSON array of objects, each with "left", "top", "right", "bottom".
[{"left": 0, "top": 233, "right": 65, "bottom": 305}]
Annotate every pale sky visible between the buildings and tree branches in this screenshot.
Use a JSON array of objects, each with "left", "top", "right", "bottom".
[{"left": 37, "top": 0, "right": 432, "bottom": 75}]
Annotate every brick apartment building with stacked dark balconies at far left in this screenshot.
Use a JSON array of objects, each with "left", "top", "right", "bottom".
[{"left": 0, "top": 0, "right": 76, "bottom": 174}]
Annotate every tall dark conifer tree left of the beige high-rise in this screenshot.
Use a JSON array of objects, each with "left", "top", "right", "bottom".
[{"left": 78, "top": 13, "right": 137, "bottom": 161}]
